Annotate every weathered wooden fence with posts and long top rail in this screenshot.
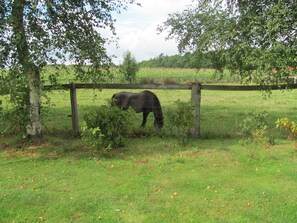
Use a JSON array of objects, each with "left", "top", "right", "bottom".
[{"left": 44, "top": 82, "right": 297, "bottom": 137}]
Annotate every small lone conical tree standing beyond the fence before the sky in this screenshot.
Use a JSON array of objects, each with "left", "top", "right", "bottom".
[{"left": 120, "top": 50, "right": 139, "bottom": 83}]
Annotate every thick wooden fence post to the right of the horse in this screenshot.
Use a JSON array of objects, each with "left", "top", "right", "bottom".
[{"left": 191, "top": 83, "right": 201, "bottom": 137}]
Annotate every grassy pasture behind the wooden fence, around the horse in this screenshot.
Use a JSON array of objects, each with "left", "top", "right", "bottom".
[{"left": 41, "top": 89, "right": 297, "bottom": 139}]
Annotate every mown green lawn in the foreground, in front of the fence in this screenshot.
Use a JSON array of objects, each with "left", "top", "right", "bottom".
[{"left": 0, "top": 136, "right": 297, "bottom": 222}]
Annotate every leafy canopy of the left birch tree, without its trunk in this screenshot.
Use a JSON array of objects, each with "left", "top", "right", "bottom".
[{"left": 0, "top": 0, "right": 134, "bottom": 80}]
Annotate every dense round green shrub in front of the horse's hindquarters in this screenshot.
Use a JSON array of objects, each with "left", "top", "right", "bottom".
[{"left": 82, "top": 104, "right": 134, "bottom": 149}]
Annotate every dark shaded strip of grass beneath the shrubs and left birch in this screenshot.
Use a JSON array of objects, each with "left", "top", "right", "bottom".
[{"left": 0, "top": 127, "right": 238, "bottom": 164}]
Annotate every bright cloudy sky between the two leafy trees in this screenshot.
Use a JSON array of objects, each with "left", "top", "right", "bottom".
[{"left": 106, "top": 0, "right": 192, "bottom": 64}]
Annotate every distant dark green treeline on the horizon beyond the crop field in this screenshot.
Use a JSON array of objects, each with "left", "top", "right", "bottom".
[{"left": 139, "top": 52, "right": 216, "bottom": 68}]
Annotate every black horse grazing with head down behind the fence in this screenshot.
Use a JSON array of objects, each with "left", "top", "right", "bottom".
[{"left": 112, "top": 91, "right": 164, "bottom": 128}]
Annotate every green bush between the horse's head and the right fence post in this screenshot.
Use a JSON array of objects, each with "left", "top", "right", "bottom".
[{"left": 166, "top": 100, "right": 194, "bottom": 145}]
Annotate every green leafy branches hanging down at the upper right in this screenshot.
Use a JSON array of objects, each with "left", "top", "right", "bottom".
[{"left": 159, "top": 0, "right": 297, "bottom": 85}]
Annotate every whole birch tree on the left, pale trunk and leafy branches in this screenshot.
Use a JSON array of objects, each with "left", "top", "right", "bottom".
[{"left": 0, "top": 0, "right": 134, "bottom": 136}]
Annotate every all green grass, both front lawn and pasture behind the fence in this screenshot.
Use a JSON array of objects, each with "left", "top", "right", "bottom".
[{"left": 0, "top": 68, "right": 297, "bottom": 223}]
